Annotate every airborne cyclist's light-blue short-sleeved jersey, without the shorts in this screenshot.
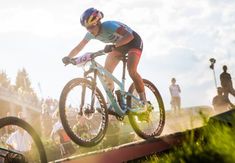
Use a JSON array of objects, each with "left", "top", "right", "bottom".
[{"left": 84, "top": 21, "right": 133, "bottom": 43}]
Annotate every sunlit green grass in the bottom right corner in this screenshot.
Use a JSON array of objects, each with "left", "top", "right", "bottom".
[{"left": 138, "top": 111, "right": 235, "bottom": 163}]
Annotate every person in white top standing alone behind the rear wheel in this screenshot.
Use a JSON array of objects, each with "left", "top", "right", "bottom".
[{"left": 169, "top": 78, "right": 181, "bottom": 112}]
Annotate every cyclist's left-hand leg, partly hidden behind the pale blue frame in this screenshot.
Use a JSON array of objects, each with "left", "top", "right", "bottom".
[{"left": 104, "top": 50, "right": 122, "bottom": 91}]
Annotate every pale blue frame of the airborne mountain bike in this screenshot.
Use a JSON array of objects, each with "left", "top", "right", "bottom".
[{"left": 84, "top": 53, "right": 140, "bottom": 116}]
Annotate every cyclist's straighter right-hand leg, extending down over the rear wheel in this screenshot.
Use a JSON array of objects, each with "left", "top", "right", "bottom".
[{"left": 127, "top": 48, "right": 146, "bottom": 102}]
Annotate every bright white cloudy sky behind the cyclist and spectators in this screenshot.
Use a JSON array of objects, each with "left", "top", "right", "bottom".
[{"left": 0, "top": 0, "right": 235, "bottom": 108}]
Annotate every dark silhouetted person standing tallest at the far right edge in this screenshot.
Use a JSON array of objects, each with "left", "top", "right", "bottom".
[{"left": 220, "top": 65, "right": 235, "bottom": 107}]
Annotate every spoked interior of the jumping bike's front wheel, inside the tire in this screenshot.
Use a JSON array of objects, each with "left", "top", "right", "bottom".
[{"left": 63, "top": 84, "right": 105, "bottom": 140}]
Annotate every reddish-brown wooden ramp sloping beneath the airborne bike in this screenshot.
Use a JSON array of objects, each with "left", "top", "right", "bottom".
[{"left": 50, "top": 128, "right": 200, "bottom": 163}]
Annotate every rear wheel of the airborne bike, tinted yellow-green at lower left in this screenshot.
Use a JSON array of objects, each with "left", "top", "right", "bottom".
[{"left": 127, "top": 79, "right": 165, "bottom": 139}]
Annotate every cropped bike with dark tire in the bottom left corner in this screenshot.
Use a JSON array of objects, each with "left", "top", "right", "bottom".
[{"left": 0, "top": 117, "right": 47, "bottom": 163}]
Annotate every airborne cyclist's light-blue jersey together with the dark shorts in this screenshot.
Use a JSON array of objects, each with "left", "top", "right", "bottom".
[{"left": 84, "top": 21, "right": 143, "bottom": 54}]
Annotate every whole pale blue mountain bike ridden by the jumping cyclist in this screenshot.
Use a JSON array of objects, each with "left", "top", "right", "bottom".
[{"left": 59, "top": 50, "right": 165, "bottom": 147}]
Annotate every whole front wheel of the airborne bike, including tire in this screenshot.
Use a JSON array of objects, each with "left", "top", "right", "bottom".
[{"left": 59, "top": 78, "right": 108, "bottom": 147}]
